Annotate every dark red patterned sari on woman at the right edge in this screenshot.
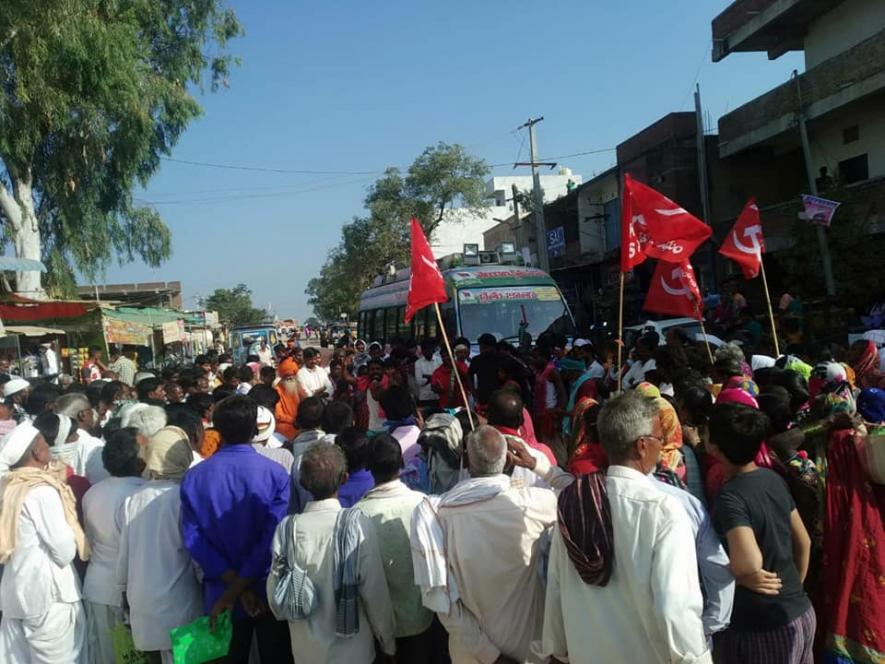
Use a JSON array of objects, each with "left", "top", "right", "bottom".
[{"left": 818, "top": 429, "right": 885, "bottom": 664}]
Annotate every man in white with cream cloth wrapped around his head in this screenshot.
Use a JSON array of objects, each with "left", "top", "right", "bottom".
[{"left": 116, "top": 427, "right": 203, "bottom": 664}]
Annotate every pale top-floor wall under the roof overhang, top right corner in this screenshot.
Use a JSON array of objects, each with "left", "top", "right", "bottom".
[{"left": 805, "top": 0, "right": 885, "bottom": 70}]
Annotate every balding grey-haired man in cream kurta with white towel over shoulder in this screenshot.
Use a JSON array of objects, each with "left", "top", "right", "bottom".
[{"left": 411, "top": 425, "right": 556, "bottom": 664}]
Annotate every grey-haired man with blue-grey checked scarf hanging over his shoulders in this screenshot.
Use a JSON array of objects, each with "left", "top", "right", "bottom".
[{"left": 267, "top": 442, "right": 396, "bottom": 664}]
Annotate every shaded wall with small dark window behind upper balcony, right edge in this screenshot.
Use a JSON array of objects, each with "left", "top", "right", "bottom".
[{"left": 809, "top": 96, "right": 885, "bottom": 178}]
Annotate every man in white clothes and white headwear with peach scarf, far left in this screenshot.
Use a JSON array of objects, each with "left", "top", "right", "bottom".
[{"left": 0, "top": 422, "right": 89, "bottom": 664}]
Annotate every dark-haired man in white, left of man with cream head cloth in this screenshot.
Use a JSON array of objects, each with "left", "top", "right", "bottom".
[{"left": 83, "top": 429, "right": 144, "bottom": 664}]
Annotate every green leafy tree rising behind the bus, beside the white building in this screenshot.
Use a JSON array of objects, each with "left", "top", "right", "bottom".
[{"left": 306, "top": 143, "right": 490, "bottom": 320}]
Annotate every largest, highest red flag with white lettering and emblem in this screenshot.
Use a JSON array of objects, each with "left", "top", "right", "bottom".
[{"left": 621, "top": 173, "right": 712, "bottom": 272}]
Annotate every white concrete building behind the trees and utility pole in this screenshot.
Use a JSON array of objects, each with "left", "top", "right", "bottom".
[{"left": 430, "top": 168, "right": 583, "bottom": 263}]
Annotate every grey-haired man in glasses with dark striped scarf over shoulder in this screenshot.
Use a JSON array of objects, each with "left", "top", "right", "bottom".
[{"left": 538, "top": 392, "right": 712, "bottom": 664}]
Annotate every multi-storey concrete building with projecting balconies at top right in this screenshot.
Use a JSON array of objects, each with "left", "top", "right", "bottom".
[{"left": 712, "top": 0, "right": 885, "bottom": 246}]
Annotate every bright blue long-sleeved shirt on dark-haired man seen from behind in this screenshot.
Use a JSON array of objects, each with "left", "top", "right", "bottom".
[{"left": 181, "top": 444, "right": 289, "bottom": 613}]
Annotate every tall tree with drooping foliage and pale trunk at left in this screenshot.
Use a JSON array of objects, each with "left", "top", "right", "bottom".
[{"left": 0, "top": 0, "right": 241, "bottom": 297}]
